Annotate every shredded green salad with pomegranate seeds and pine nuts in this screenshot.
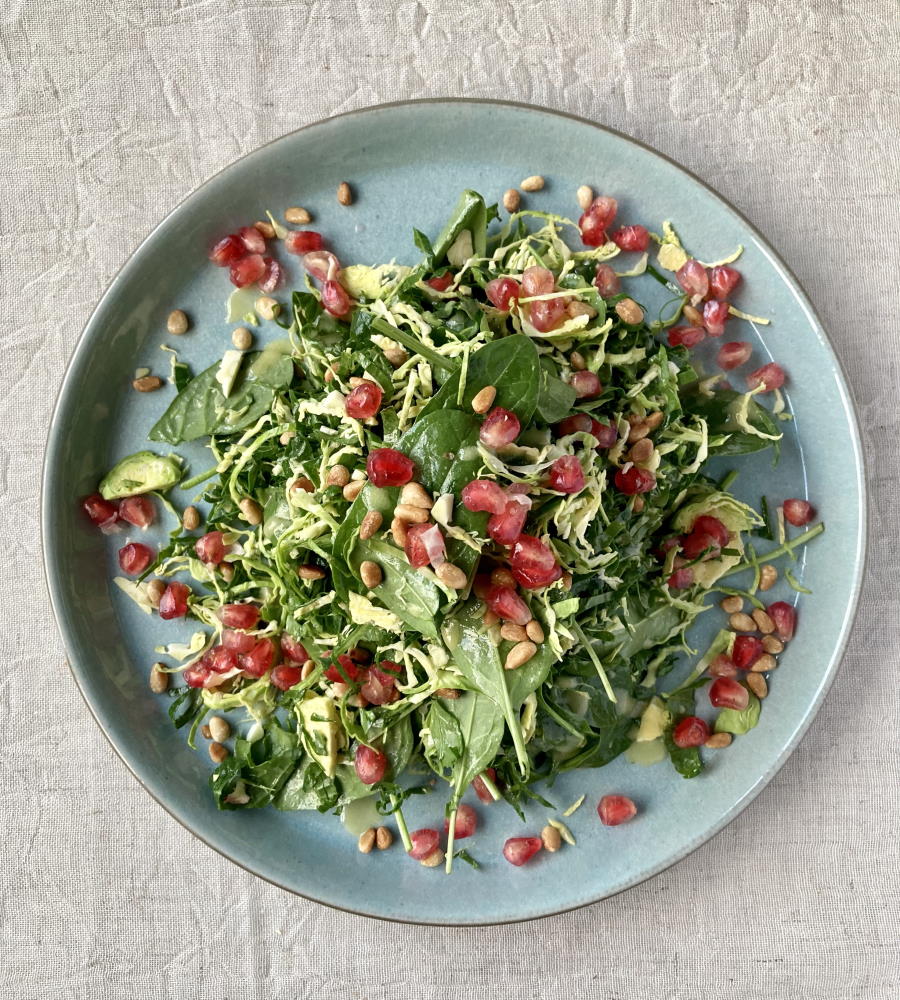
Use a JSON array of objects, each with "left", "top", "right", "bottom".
[{"left": 83, "top": 184, "right": 823, "bottom": 872}]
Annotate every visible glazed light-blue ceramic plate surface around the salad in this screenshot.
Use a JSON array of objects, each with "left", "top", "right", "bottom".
[{"left": 43, "top": 100, "right": 865, "bottom": 924}]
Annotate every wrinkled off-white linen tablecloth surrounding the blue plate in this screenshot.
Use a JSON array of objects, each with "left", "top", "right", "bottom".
[{"left": 0, "top": 0, "right": 900, "bottom": 1000}]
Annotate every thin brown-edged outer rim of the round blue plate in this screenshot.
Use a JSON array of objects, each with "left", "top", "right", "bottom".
[{"left": 39, "top": 97, "right": 870, "bottom": 927}]
